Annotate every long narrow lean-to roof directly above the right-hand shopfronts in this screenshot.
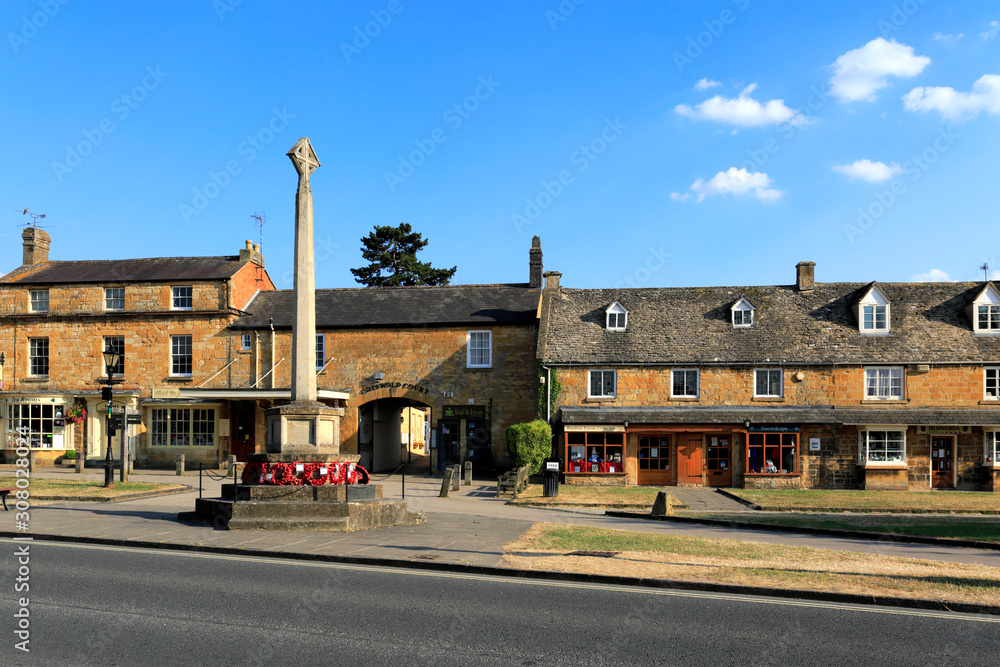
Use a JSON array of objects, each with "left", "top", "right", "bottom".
[{"left": 560, "top": 405, "right": 1000, "bottom": 425}]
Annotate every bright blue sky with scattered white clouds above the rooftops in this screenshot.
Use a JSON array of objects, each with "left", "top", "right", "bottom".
[{"left": 0, "top": 0, "right": 1000, "bottom": 287}]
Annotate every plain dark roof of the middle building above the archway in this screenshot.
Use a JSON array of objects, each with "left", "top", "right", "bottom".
[{"left": 233, "top": 285, "right": 541, "bottom": 329}]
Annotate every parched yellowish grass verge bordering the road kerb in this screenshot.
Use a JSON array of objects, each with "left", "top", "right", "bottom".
[{"left": 504, "top": 523, "right": 1000, "bottom": 606}]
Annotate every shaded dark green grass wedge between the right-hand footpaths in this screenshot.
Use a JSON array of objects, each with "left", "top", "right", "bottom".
[{"left": 706, "top": 512, "right": 1000, "bottom": 544}]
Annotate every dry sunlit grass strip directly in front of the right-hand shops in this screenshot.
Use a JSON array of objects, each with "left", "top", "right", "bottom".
[{"left": 727, "top": 489, "right": 1000, "bottom": 514}]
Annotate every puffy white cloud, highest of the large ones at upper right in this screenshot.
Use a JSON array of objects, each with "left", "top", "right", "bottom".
[{"left": 830, "top": 37, "right": 931, "bottom": 102}]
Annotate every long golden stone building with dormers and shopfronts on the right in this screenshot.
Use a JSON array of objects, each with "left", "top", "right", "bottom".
[{"left": 538, "top": 262, "right": 1000, "bottom": 491}]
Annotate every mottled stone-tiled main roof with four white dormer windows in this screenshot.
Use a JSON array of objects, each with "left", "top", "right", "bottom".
[{"left": 539, "top": 282, "right": 1000, "bottom": 365}]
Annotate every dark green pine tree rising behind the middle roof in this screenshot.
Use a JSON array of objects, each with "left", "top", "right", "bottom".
[{"left": 351, "top": 222, "right": 458, "bottom": 287}]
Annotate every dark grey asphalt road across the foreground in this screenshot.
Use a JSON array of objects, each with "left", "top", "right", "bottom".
[{"left": 0, "top": 540, "right": 1000, "bottom": 667}]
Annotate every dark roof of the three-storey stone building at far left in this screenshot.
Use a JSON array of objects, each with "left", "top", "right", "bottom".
[{"left": 0, "top": 256, "right": 249, "bottom": 285}]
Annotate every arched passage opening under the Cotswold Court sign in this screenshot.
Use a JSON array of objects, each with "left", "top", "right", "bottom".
[{"left": 358, "top": 398, "right": 431, "bottom": 472}]
